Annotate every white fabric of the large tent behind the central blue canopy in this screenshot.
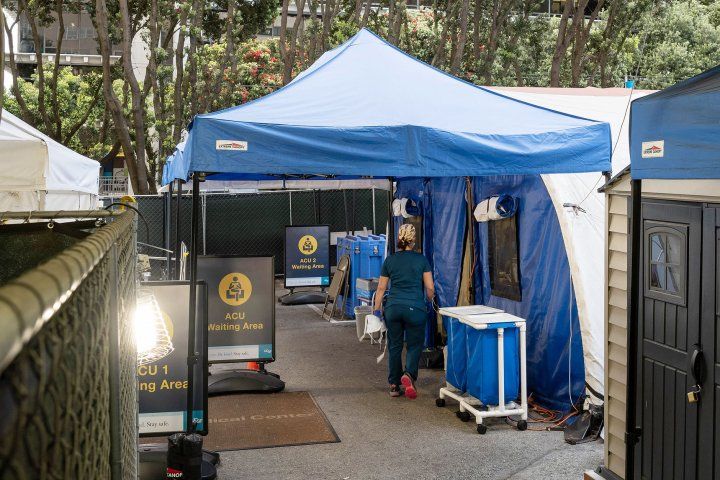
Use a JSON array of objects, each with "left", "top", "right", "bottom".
[{"left": 492, "top": 87, "right": 652, "bottom": 394}]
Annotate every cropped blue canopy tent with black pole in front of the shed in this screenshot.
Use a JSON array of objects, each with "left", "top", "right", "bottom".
[{"left": 625, "top": 66, "right": 720, "bottom": 480}]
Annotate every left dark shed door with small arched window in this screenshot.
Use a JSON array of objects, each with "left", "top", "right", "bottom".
[{"left": 636, "top": 201, "right": 707, "bottom": 480}]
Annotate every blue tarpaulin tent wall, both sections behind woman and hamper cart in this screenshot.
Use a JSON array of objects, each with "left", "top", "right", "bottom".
[{"left": 395, "top": 175, "right": 585, "bottom": 411}]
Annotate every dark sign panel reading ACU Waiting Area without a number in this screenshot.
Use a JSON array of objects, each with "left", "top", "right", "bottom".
[{"left": 198, "top": 255, "right": 275, "bottom": 363}]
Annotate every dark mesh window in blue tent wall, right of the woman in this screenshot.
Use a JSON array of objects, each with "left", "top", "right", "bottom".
[{"left": 488, "top": 215, "right": 522, "bottom": 302}]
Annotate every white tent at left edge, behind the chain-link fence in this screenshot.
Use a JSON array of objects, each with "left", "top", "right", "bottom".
[{"left": 0, "top": 111, "right": 100, "bottom": 211}]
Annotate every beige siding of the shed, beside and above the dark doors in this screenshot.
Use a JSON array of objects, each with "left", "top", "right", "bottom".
[{"left": 604, "top": 174, "right": 720, "bottom": 478}]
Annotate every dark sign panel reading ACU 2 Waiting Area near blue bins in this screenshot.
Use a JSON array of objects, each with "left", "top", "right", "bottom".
[{"left": 285, "top": 225, "right": 330, "bottom": 288}]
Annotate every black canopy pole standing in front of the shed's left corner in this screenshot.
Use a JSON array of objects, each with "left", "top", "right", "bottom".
[{"left": 625, "top": 180, "right": 643, "bottom": 480}]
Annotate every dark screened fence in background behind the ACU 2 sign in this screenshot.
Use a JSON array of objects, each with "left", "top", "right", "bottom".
[{"left": 131, "top": 189, "right": 388, "bottom": 279}]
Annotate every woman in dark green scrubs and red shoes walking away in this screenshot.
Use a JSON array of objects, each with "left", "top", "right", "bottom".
[{"left": 374, "top": 224, "right": 435, "bottom": 398}]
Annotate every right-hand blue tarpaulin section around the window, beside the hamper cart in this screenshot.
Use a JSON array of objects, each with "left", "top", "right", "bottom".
[{"left": 473, "top": 175, "right": 585, "bottom": 411}]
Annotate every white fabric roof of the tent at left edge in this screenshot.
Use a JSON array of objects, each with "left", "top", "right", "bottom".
[{"left": 0, "top": 110, "right": 100, "bottom": 195}]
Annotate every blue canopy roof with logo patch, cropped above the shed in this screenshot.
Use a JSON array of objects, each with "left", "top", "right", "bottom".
[{"left": 630, "top": 66, "right": 720, "bottom": 179}]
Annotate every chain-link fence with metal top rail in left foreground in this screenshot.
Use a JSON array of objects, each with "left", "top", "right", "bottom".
[{"left": 0, "top": 213, "right": 138, "bottom": 480}]
